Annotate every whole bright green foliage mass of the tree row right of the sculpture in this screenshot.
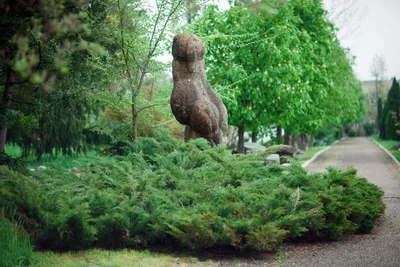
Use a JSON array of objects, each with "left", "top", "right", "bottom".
[{"left": 191, "top": 0, "right": 365, "bottom": 137}]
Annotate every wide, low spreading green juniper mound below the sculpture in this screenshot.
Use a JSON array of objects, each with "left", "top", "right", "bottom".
[{"left": 0, "top": 134, "right": 384, "bottom": 251}]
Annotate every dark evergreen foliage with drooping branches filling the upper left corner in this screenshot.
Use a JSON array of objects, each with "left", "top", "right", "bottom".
[{"left": 0, "top": 0, "right": 104, "bottom": 157}]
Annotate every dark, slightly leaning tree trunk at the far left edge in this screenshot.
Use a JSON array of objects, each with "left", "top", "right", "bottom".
[{"left": 0, "top": 69, "right": 15, "bottom": 153}]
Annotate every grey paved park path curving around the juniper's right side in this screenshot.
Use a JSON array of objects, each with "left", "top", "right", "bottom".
[{"left": 276, "top": 137, "right": 400, "bottom": 267}]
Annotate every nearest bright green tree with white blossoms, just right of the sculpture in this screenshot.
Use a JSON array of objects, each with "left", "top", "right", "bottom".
[{"left": 194, "top": 3, "right": 309, "bottom": 152}]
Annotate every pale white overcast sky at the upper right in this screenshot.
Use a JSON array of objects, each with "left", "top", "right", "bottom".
[{"left": 220, "top": 0, "right": 400, "bottom": 80}]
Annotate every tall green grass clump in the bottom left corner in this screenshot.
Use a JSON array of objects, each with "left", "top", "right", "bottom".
[{"left": 0, "top": 212, "right": 33, "bottom": 267}]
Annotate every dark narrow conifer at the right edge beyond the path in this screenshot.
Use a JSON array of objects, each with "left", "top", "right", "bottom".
[{"left": 383, "top": 78, "right": 400, "bottom": 140}]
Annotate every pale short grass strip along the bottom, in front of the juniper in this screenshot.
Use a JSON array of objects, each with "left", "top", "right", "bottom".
[{"left": 33, "top": 249, "right": 217, "bottom": 267}]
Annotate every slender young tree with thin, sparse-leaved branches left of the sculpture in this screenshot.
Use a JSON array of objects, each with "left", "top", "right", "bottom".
[{"left": 115, "top": 0, "right": 184, "bottom": 142}]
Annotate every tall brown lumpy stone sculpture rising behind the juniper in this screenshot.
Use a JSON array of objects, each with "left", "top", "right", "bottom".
[{"left": 171, "top": 33, "right": 228, "bottom": 145}]
